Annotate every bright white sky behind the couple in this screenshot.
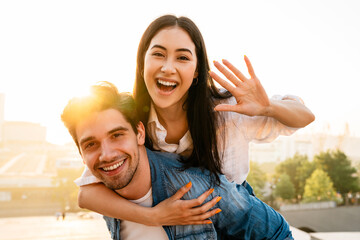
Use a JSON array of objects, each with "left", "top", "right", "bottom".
[{"left": 0, "top": 0, "right": 360, "bottom": 144}]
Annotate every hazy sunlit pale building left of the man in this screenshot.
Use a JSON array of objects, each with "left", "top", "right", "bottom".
[{"left": 0, "top": 142, "right": 83, "bottom": 218}]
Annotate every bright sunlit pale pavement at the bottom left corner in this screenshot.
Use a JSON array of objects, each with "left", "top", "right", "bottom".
[{"left": 0, "top": 215, "right": 110, "bottom": 240}]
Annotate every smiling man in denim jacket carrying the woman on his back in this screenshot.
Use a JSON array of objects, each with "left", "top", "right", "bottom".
[{"left": 62, "top": 83, "right": 292, "bottom": 239}]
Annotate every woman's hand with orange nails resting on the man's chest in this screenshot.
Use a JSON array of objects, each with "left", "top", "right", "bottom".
[{"left": 148, "top": 182, "right": 221, "bottom": 226}]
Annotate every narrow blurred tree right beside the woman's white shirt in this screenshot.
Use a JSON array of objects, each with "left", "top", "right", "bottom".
[{"left": 246, "top": 161, "right": 266, "bottom": 200}]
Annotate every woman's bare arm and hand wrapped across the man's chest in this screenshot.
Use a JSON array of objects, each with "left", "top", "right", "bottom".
[{"left": 78, "top": 183, "right": 222, "bottom": 226}]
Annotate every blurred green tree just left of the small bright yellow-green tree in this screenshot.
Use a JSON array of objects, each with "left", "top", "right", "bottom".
[{"left": 275, "top": 154, "right": 315, "bottom": 201}]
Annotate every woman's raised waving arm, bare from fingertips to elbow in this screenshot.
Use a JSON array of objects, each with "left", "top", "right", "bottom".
[{"left": 210, "top": 56, "right": 315, "bottom": 128}]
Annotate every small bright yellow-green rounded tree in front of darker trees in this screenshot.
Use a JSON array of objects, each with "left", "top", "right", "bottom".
[{"left": 303, "top": 168, "right": 336, "bottom": 202}]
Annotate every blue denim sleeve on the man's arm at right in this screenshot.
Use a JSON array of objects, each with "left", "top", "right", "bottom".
[{"left": 212, "top": 177, "right": 293, "bottom": 240}]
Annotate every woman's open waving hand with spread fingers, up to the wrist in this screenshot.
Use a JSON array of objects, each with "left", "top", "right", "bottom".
[{"left": 209, "top": 56, "right": 270, "bottom": 116}]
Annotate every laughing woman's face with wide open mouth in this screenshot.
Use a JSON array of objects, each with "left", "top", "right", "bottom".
[{"left": 144, "top": 27, "right": 197, "bottom": 109}]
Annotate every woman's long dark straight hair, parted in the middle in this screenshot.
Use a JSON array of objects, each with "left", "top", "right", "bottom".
[{"left": 134, "top": 15, "right": 231, "bottom": 183}]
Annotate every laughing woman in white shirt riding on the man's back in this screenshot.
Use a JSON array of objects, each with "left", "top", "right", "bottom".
[{"left": 79, "top": 15, "right": 314, "bottom": 225}]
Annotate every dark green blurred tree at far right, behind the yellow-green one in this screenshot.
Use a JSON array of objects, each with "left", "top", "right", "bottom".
[{"left": 314, "top": 150, "right": 360, "bottom": 202}]
